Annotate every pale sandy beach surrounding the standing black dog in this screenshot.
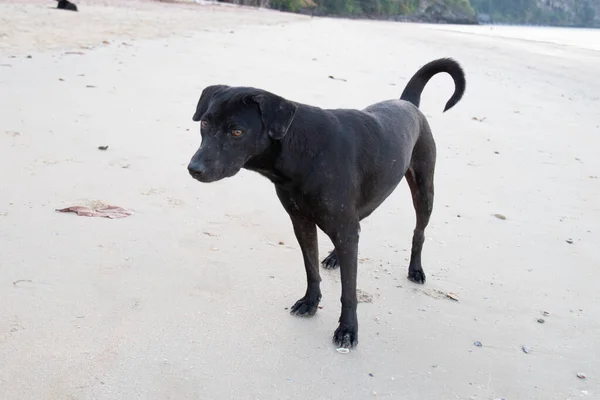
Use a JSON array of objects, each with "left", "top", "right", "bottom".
[{"left": 0, "top": 0, "right": 600, "bottom": 400}]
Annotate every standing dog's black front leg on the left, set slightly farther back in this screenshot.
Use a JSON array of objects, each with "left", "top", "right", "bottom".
[{"left": 291, "top": 216, "right": 321, "bottom": 316}]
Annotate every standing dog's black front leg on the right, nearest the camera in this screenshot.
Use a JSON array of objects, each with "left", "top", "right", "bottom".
[{"left": 331, "top": 221, "right": 360, "bottom": 348}]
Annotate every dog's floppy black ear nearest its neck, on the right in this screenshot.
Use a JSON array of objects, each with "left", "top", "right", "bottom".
[{"left": 252, "top": 93, "right": 298, "bottom": 140}]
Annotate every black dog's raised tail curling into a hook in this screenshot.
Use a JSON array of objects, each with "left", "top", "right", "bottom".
[{"left": 400, "top": 58, "right": 467, "bottom": 112}]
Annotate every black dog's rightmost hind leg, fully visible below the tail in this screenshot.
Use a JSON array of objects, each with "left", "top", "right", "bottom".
[{"left": 405, "top": 127, "right": 436, "bottom": 283}]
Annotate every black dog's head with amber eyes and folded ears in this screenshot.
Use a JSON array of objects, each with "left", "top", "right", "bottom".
[{"left": 188, "top": 85, "right": 297, "bottom": 182}]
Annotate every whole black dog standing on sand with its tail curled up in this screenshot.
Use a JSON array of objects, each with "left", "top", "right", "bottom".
[{"left": 188, "top": 59, "right": 466, "bottom": 347}]
